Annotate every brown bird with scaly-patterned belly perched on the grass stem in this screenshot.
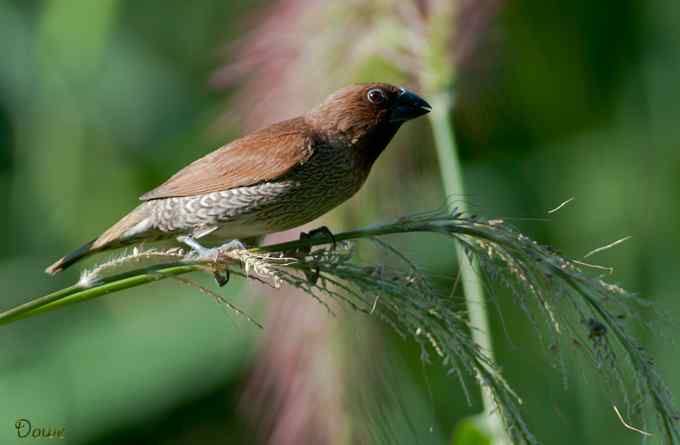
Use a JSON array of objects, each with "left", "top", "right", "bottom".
[{"left": 45, "top": 82, "right": 432, "bottom": 275}]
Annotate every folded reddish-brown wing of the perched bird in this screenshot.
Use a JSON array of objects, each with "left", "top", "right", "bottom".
[{"left": 139, "top": 118, "right": 313, "bottom": 201}]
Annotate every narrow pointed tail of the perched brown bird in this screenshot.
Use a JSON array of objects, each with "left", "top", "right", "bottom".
[{"left": 45, "top": 204, "right": 147, "bottom": 275}]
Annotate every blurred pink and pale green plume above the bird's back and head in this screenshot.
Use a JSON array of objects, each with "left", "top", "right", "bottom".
[{"left": 211, "top": 0, "right": 502, "bottom": 128}]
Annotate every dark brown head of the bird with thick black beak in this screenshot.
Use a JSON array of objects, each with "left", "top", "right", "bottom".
[{"left": 305, "top": 83, "right": 431, "bottom": 166}]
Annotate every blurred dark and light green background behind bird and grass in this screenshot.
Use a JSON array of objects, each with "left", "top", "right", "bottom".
[{"left": 0, "top": 0, "right": 680, "bottom": 445}]
